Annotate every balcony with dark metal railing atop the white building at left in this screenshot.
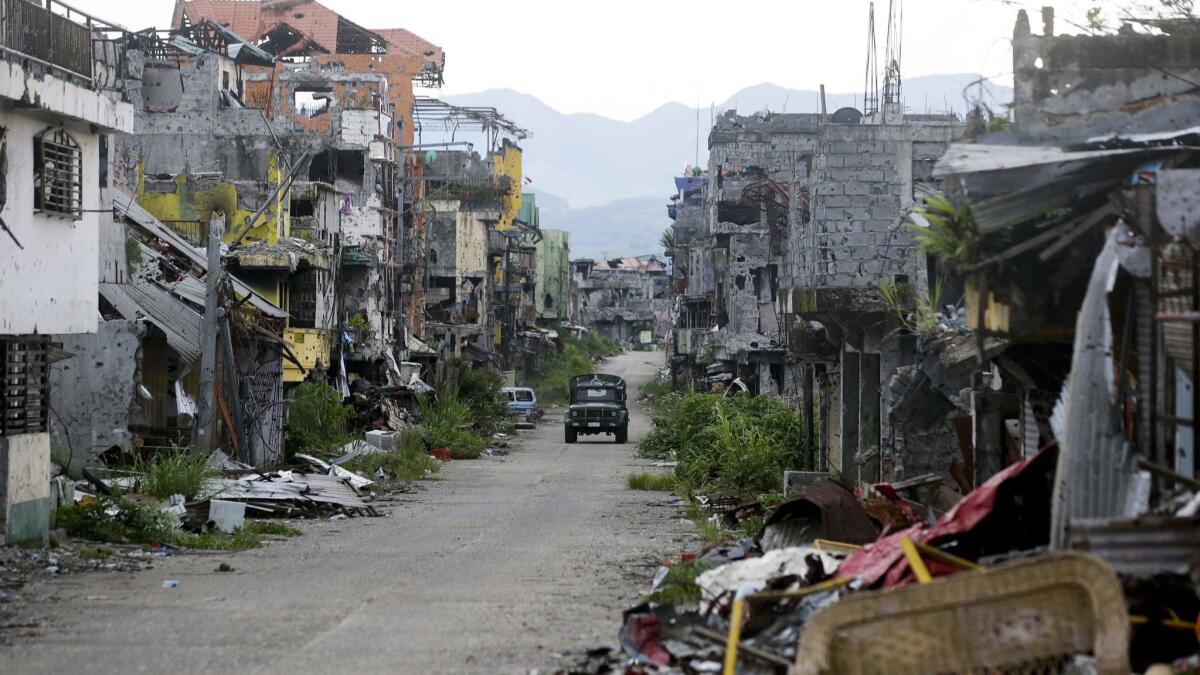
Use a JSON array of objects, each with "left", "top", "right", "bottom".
[{"left": 0, "top": 0, "right": 125, "bottom": 89}]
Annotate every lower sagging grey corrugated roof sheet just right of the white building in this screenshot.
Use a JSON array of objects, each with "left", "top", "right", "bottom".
[{"left": 100, "top": 281, "right": 204, "bottom": 363}]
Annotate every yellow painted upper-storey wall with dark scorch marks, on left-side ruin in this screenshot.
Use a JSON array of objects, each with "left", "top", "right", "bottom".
[{"left": 138, "top": 153, "right": 290, "bottom": 244}]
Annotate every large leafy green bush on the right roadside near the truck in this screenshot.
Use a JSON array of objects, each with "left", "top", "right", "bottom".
[{"left": 638, "top": 394, "right": 811, "bottom": 497}]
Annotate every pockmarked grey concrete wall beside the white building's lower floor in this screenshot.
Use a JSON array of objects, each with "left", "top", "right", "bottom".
[{"left": 50, "top": 319, "right": 145, "bottom": 467}]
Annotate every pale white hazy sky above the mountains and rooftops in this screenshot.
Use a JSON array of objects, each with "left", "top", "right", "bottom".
[{"left": 68, "top": 0, "right": 1108, "bottom": 120}]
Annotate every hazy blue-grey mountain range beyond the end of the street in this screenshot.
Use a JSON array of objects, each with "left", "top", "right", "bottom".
[{"left": 441, "top": 73, "right": 1013, "bottom": 258}]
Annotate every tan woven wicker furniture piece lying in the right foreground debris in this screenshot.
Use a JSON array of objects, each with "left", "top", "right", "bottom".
[{"left": 793, "top": 552, "right": 1129, "bottom": 675}]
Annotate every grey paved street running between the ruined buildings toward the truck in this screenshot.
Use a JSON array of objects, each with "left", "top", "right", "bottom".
[{"left": 0, "top": 353, "right": 696, "bottom": 675}]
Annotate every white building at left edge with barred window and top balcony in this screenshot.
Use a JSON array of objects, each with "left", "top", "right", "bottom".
[{"left": 0, "top": 4, "right": 133, "bottom": 543}]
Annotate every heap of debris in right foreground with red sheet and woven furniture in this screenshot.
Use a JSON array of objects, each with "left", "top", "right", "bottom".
[{"left": 564, "top": 461, "right": 1200, "bottom": 675}]
